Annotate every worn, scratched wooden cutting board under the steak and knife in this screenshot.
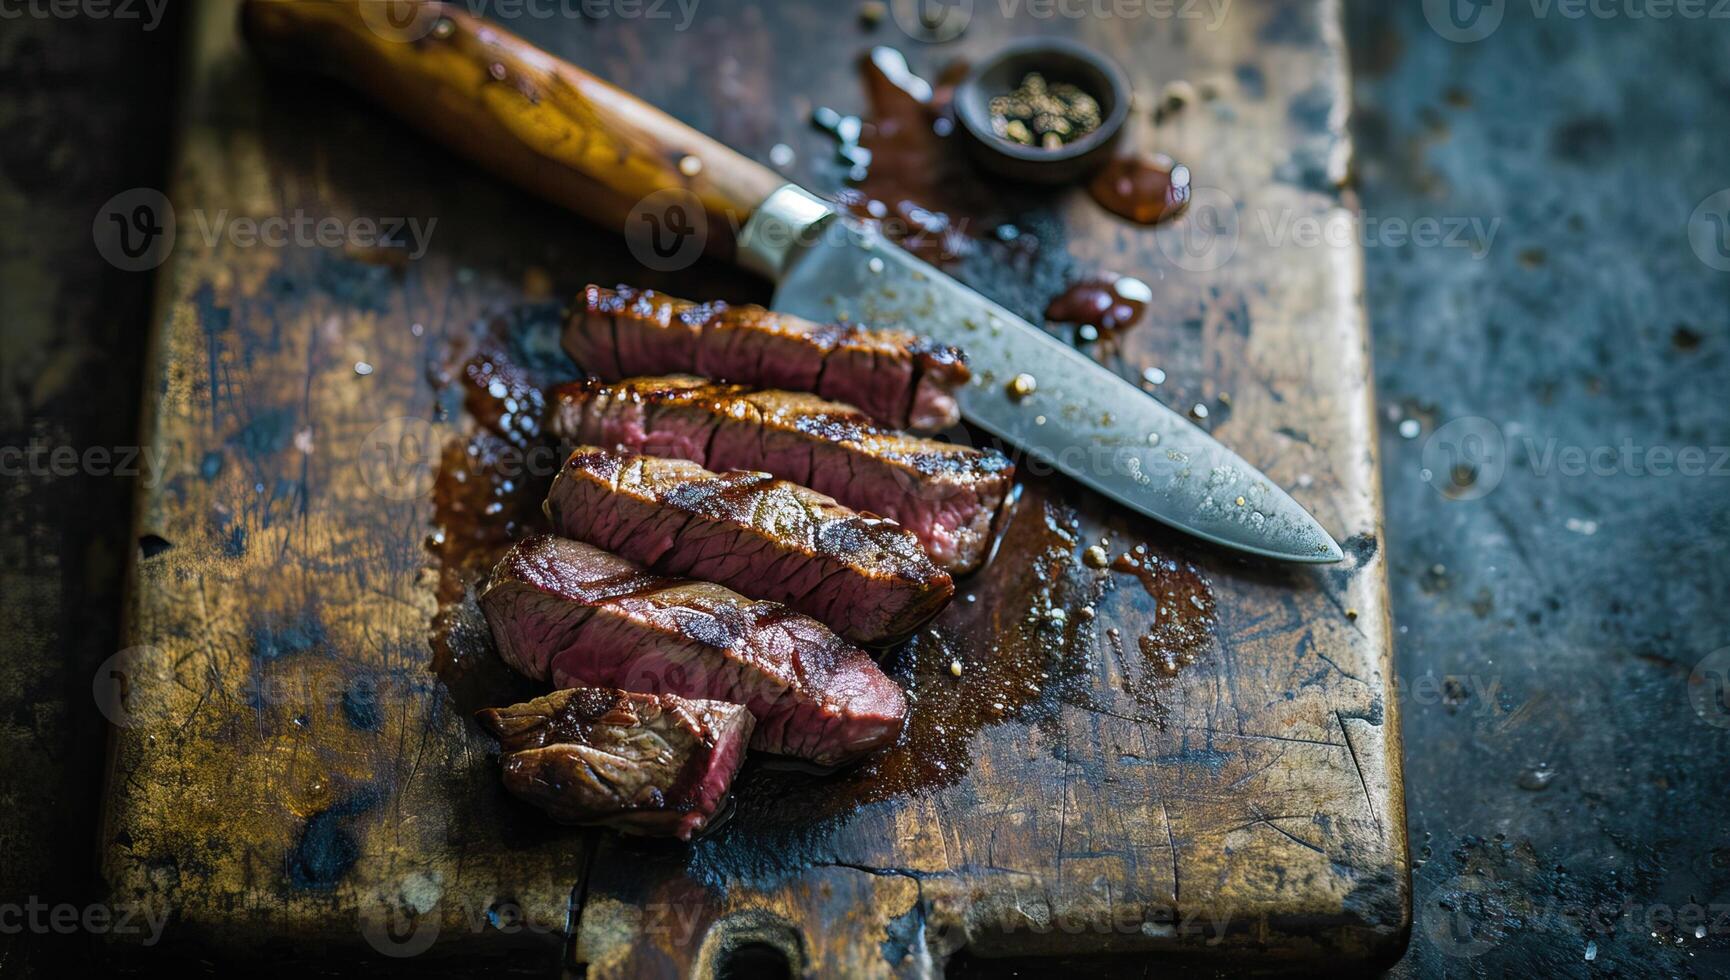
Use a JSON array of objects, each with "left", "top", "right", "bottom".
[{"left": 95, "top": 0, "right": 1410, "bottom": 977}]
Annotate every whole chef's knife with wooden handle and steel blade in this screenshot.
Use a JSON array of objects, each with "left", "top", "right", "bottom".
[{"left": 242, "top": 0, "right": 1341, "bottom": 561}]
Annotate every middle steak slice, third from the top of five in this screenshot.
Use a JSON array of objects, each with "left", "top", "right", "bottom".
[{"left": 547, "top": 447, "right": 955, "bottom": 646}]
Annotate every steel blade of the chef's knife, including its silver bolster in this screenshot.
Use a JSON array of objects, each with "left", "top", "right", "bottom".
[{"left": 739, "top": 184, "right": 1342, "bottom": 563}]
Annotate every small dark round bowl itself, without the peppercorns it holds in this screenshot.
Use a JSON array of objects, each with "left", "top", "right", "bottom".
[{"left": 955, "top": 38, "right": 1130, "bottom": 184}]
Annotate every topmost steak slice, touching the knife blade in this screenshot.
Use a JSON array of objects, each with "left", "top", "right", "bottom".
[{"left": 564, "top": 286, "right": 972, "bottom": 431}]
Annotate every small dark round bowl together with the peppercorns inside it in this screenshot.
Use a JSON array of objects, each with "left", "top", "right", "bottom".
[{"left": 955, "top": 38, "right": 1130, "bottom": 184}]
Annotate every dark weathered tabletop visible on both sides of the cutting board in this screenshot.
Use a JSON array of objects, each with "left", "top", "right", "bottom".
[{"left": 0, "top": 0, "right": 1730, "bottom": 977}]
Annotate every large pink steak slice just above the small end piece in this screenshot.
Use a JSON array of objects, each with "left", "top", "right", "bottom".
[{"left": 481, "top": 535, "right": 907, "bottom": 765}]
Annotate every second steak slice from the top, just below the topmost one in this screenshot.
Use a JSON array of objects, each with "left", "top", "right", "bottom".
[{"left": 548, "top": 376, "right": 1016, "bottom": 573}]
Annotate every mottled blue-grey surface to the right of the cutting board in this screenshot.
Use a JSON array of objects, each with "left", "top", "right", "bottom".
[{"left": 1351, "top": 2, "right": 1730, "bottom": 977}]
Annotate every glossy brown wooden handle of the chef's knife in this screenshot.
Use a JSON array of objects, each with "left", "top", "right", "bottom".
[{"left": 240, "top": 0, "right": 785, "bottom": 258}]
